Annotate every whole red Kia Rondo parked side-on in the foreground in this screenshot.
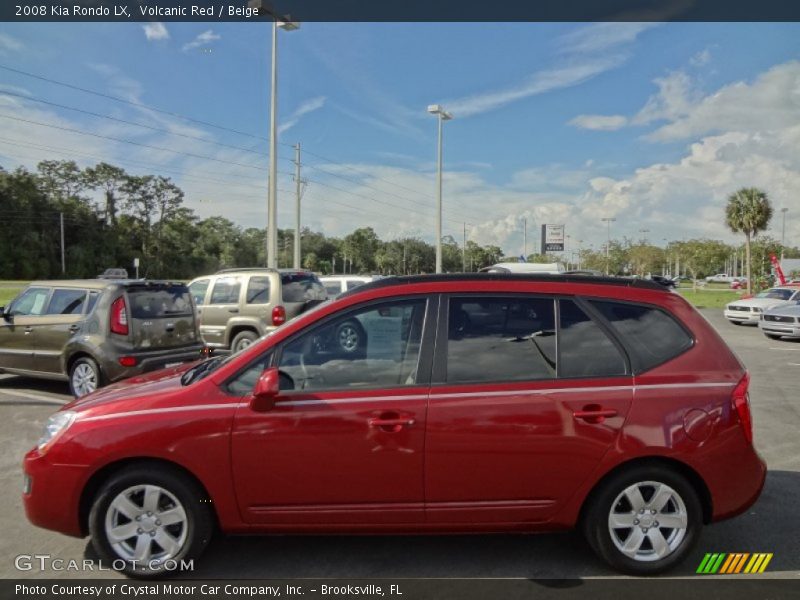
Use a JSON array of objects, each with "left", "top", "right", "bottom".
[{"left": 24, "top": 274, "right": 766, "bottom": 576}]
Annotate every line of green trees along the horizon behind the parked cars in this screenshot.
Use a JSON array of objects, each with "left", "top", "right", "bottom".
[{"left": 0, "top": 161, "right": 800, "bottom": 280}]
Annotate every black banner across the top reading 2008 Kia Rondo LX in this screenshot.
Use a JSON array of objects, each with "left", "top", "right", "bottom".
[{"left": 0, "top": 0, "right": 800, "bottom": 22}]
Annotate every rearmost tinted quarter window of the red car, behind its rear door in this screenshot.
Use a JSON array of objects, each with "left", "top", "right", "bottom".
[{"left": 589, "top": 300, "right": 693, "bottom": 372}]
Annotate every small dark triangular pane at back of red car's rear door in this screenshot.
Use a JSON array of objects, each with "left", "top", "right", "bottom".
[{"left": 558, "top": 300, "right": 626, "bottom": 377}]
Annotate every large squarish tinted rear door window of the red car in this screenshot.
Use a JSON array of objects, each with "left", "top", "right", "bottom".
[{"left": 447, "top": 297, "right": 556, "bottom": 383}]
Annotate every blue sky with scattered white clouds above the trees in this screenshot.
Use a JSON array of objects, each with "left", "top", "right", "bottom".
[{"left": 0, "top": 22, "right": 800, "bottom": 259}]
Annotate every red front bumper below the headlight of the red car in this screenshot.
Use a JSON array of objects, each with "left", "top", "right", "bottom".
[{"left": 22, "top": 448, "right": 86, "bottom": 537}]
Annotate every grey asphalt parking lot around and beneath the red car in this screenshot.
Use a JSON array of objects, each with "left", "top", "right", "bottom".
[{"left": 0, "top": 310, "right": 800, "bottom": 579}]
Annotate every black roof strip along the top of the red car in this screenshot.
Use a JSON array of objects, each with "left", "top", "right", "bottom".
[{"left": 339, "top": 273, "right": 670, "bottom": 298}]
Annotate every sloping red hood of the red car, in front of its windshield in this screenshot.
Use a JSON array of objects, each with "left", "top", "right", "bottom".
[{"left": 64, "top": 362, "right": 196, "bottom": 412}]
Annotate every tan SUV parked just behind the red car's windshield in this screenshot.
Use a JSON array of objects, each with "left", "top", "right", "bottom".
[{"left": 189, "top": 269, "right": 327, "bottom": 352}]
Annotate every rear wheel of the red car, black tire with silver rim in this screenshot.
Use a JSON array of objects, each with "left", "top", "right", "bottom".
[{"left": 583, "top": 466, "right": 703, "bottom": 575}]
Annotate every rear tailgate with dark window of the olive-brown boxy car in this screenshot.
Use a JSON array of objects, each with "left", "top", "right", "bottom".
[{"left": 127, "top": 284, "right": 198, "bottom": 350}]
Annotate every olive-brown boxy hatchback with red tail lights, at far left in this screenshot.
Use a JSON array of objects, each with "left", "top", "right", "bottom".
[{"left": 0, "top": 279, "right": 203, "bottom": 397}]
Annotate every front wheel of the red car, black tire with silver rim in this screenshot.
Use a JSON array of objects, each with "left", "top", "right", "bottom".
[{"left": 89, "top": 466, "right": 215, "bottom": 578}]
